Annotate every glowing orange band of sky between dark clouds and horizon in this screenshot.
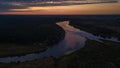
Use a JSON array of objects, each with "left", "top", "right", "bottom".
[{"left": 0, "top": 3, "right": 120, "bottom": 15}]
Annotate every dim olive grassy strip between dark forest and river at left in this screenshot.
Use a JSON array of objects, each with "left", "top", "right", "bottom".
[{"left": 0, "top": 43, "right": 47, "bottom": 57}]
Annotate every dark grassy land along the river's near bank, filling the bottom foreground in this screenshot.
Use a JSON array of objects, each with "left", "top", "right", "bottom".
[{"left": 0, "top": 40, "right": 120, "bottom": 68}]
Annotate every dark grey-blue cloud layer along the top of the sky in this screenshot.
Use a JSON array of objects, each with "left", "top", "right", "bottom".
[{"left": 0, "top": 0, "right": 117, "bottom": 12}]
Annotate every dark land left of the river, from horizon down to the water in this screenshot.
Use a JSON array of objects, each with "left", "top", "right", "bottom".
[{"left": 0, "top": 15, "right": 65, "bottom": 57}]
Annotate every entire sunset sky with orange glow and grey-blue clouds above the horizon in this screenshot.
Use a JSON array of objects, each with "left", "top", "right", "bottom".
[{"left": 0, "top": 0, "right": 120, "bottom": 15}]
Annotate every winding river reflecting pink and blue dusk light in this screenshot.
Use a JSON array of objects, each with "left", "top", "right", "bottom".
[{"left": 0, "top": 21, "right": 119, "bottom": 63}]
